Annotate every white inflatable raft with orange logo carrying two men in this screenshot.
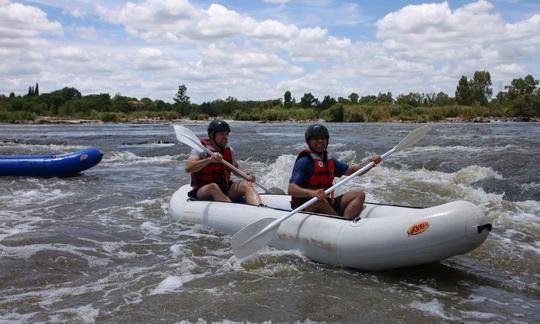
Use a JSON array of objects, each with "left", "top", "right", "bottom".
[{"left": 169, "top": 185, "right": 491, "bottom": 270}]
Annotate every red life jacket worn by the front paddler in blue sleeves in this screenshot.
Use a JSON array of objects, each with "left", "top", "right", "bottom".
[{"left": 291, "top": 149, "right": 336, "bottom": 206}]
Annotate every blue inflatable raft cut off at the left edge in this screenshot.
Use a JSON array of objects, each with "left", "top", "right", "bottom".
[{"left": 0, "top": 148, "right": 103, "bottom": 177}]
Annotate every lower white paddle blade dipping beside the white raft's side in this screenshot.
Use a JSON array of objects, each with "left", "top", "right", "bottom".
[{"left": 231, "top": 218, "right": 279, "bottom": 259}]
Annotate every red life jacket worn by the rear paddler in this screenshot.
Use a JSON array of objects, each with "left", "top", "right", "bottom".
[{"left": 191, "top": 139, "right": 233, "bottom": 193}]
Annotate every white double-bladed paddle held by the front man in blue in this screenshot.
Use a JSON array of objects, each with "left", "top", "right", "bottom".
[{"left": 231, "top": 126, "right": 431, "bottom": 258}]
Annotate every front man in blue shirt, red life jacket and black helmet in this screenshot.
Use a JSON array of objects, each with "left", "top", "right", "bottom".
[{"left": 288, "top": 124, "right": 381, "bottom": 219}]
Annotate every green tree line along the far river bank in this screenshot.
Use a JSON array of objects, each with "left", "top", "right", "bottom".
[{"left": 0, "top": 71, "right": 540, "bottom": 122}]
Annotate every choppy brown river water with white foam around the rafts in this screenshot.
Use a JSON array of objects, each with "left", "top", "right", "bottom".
[{"left": 0, "top": 121, "right": 540, "bottom": 323}]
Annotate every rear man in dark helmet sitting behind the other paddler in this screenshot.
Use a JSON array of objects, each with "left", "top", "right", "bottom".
[{"left": 186, "top": 119, "right": 262, "bottom": 205}]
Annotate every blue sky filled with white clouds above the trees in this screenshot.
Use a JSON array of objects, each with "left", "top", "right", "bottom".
[{"left": 0, "top": 0, "right": 540, "bottom": 103}]
